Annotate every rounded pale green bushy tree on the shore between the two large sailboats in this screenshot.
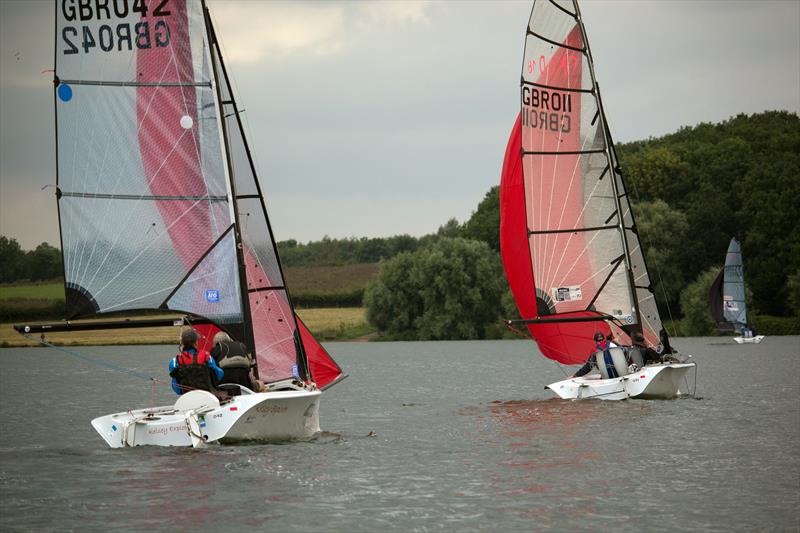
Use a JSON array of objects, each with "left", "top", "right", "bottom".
[{"left": 364, "top": 238, "right": 504, "bottom": 340}]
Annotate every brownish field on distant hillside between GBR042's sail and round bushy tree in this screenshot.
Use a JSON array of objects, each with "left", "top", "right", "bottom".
[{"left": 284, "top": 263, "right": 380, "bottom": 294}]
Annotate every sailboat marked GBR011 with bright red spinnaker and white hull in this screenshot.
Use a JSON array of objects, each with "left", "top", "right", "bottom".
[{"left": 500, "top": 0, "right": 695, "bottom": 399}]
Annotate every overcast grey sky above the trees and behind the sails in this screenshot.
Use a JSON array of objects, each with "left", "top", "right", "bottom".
[{"left": 0, "top": 0, "right": 800, "bottom": 249}]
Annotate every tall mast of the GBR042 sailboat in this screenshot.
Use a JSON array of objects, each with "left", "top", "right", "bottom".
[{"left": 203, "top": 0, "right": 258, "bottom": 358}]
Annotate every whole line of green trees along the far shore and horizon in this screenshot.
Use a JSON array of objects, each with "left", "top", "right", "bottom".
[{"left": 0, "top": 111, "right": 800, "bottom": 338}]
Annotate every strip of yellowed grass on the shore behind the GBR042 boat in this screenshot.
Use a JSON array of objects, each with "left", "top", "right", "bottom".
[{"left": 0, "top": 308, "right": 367, "bottom": 347}]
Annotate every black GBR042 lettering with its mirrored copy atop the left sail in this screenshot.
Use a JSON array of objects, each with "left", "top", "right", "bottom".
[{"left": 61, "top": 0, "right": 171, "bottom": 55}]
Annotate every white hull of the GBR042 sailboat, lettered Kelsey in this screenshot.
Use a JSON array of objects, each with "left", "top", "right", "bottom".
[{"left": 92, "top": 389, "right": 321, "bottom": 448}]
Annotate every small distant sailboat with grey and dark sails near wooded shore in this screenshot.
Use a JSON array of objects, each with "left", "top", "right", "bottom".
[{"left": 709, "top": 237, "right": 764, "bottom": 344}]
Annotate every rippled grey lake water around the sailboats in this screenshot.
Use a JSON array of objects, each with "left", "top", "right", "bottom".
[{"left": 0, "top": 337, "right": 800, "bottom": 532}]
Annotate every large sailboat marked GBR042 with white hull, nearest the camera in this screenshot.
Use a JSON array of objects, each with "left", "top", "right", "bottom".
[{"left": 15, "top": 0, "right": 345, "bottom": 448}]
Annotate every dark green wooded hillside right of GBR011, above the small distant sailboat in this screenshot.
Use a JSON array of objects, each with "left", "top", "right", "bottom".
[{"left": 618, "top": 111, "right": 800, "bottom": 315}]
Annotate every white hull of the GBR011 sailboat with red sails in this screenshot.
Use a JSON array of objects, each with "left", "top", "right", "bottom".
[{"left": 545, "top": 363, "right": 695, "bottom": 400}]
